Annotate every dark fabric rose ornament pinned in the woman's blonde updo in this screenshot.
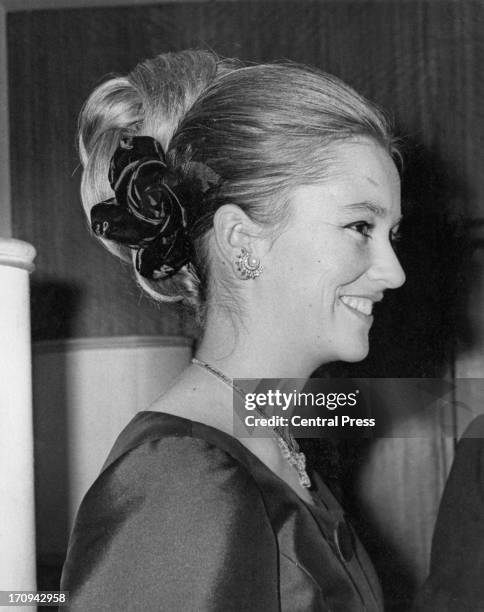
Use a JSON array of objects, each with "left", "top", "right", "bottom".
[{"left": 91, "top": 136, "right": 191, "bottom": 279}]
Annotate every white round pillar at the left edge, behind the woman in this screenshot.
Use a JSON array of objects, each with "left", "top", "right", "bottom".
[{"left": 0, "top": 239, "right": 36, "bottom": 596}]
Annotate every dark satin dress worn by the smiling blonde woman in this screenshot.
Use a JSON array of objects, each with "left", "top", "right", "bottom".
[{"left": 61, "top": 411, "right": 383, "bottom": 612}]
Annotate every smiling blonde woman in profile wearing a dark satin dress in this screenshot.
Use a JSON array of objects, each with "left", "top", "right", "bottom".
[{"left": 62, "top": 51, "right": 404, "bottom": 612}]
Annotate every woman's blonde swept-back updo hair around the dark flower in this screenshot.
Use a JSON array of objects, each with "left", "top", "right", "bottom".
[{"left": 79, "top": 51, "right": 396, "bottom": 318}]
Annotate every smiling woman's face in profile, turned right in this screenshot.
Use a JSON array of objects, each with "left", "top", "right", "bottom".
[{"left": 261, "top": 139, "right": 405, "bottom": 368}]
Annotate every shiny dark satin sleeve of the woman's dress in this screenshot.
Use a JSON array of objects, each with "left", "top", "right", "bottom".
[{"left": 61, "top": 437, "right": 280, "bottom": 612}]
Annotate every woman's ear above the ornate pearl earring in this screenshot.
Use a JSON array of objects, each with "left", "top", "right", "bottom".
[{"left": 213, "top": 204, "right": 263, "bottom": 275}]
